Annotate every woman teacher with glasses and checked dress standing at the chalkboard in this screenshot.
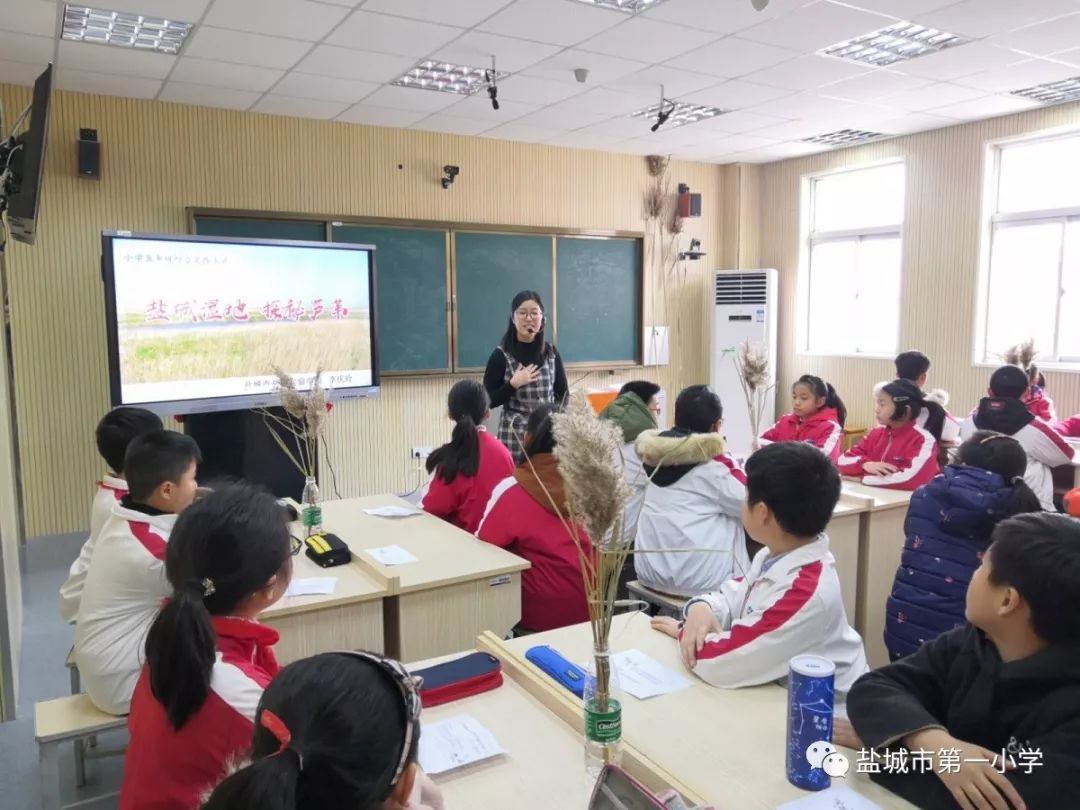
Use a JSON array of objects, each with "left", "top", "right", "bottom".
[{"left": 484, "top": 289, "right": 567, "bottom": 464}]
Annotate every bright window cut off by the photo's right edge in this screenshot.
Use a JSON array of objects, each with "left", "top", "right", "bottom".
[{"left": 976, "top": 133, "right": 1080, "bottom": 364}]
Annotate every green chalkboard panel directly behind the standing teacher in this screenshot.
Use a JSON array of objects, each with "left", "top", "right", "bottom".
[{"left": 454, "top": 231, "right": 553, "bottom": 368}]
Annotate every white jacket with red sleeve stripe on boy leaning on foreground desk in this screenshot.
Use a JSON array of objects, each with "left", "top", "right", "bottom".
[{"left": 684, "top": 534, "right": 868, "bottom": 692}]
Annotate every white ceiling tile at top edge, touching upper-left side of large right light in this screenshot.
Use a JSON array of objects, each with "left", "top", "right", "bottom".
[{"left": 739, "top": 0, "right": 895, "bottom": 52}]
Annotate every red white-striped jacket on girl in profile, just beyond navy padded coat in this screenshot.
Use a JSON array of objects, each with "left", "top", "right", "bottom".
[{"left": 837, "top": 421, "right": 941, "bottom": 490}]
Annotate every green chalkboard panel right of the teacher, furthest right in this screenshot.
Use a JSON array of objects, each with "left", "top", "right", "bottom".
[{"left": 556, "top": 237, "right": 642, "bottom": 363}]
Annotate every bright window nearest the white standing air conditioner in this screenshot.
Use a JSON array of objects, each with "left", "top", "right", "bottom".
[{"left": 802, "top": 163, "right": 904, "bottom": 355}]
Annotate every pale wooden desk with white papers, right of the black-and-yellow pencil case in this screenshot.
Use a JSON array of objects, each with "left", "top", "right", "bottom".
[{"left": 320, "top": 495, "right": 529, "bottom": 661}]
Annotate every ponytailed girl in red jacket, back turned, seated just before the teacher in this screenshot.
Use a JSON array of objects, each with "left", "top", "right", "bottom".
[{"left": 423, "top": 380, "right": 514, "bottom": 535}]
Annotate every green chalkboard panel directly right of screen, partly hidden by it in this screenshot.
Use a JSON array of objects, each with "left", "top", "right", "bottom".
[{"left": 332, "top": 225, "right": 450, "bottom": 373}]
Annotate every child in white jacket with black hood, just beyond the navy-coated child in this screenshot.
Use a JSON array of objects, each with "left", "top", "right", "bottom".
[{"left": 961, "top": 366, "right": 1075, "bottom": 512}]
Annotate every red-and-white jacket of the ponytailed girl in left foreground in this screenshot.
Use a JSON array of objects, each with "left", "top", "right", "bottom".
[{"left": 120, "top": 617, "right": 281, "bottom": 810}]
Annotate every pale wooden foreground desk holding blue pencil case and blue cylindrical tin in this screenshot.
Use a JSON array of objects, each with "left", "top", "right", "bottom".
[{"left": 480, "top": 613, "right": 913, "bottom": 810}]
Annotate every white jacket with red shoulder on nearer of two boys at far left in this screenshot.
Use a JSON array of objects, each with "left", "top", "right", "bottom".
[{"left": 75, "top": 497, "right": 176, "bottom": 714}]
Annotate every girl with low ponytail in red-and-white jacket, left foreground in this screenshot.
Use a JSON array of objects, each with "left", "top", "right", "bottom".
[{"left": 120, "top": 484, "right": 300, "bottom": 810}]
